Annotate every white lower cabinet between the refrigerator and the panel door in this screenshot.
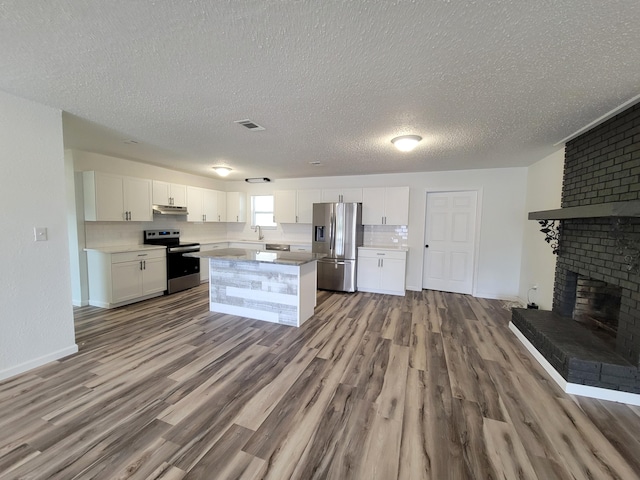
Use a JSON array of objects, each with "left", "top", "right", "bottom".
[{"left": 358, "top": 248, "right": 407, "bottom": 296}]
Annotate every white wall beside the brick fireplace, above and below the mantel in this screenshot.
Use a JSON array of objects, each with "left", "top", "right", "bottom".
[{"left": 519, "top": 148, "right": 564, "bottom": 310}]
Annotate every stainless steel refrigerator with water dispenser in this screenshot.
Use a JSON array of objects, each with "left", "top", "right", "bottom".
[{"left": 312, "top": 203, "right": 364, "bottom": 292}]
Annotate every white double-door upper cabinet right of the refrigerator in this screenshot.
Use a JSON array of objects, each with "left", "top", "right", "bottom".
[{"left": 362, "top": 187, "right": 409, "bottom": 225}]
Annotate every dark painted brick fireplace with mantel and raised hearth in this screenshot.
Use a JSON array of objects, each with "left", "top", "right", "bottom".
[{"left": 512, "top": 104, "right": 640, "bottom": 400}]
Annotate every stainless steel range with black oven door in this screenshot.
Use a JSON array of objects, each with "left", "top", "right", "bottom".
[{"left": 144, "top": 229, "right": 200, "bottom": 294}]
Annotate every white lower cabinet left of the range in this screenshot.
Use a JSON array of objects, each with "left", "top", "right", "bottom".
[{"left": 87, "top": 249, "right": 167, "bottom": 308}]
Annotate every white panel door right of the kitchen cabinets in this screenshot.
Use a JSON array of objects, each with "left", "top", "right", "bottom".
[{"left": 422, "top": 191, "right": 477, "bottom": 294}]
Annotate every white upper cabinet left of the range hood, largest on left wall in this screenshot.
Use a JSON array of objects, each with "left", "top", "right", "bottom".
[{"left": 82, "top": 171, "right": 153, "bottom": 222}]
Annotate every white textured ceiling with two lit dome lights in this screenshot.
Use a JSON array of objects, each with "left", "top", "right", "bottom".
[{"left": 0, "top": 0, "right": 640, "bottom": 180}]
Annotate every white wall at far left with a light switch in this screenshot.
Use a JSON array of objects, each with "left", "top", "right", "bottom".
[{"left": 0, "top": 92, "right": 77, "bottom": 379}]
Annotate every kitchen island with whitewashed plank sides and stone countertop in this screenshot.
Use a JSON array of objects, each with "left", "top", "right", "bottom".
[{"left": 185, "top": 248, "right": 324, "bottom": 327}]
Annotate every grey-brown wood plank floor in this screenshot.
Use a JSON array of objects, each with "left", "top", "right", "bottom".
[{"left": 0, "top": 285, "right": 640, "bottom": 480}]
